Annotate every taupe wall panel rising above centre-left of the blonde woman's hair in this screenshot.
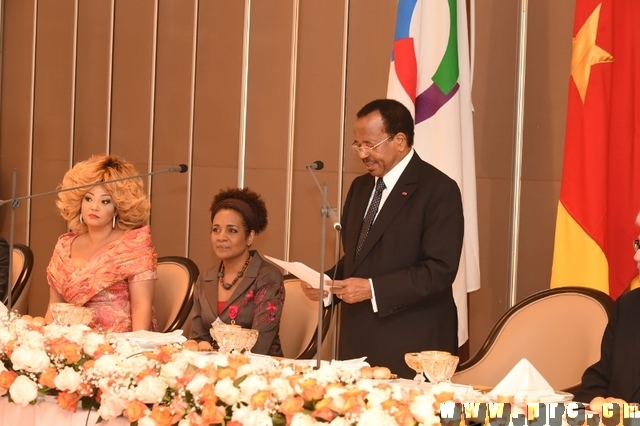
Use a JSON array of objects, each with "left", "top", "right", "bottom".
[{"left": 74, "top": 0, "right": 115, "bottom": 156}]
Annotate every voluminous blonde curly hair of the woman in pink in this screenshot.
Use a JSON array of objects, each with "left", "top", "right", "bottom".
[{"left": 56, "top": 155, "right": 151, "bottom": 233}]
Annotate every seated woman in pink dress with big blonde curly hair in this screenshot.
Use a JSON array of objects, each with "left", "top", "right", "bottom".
[{"left": 46, "top": 155, "right": 157, "bottom": 332}]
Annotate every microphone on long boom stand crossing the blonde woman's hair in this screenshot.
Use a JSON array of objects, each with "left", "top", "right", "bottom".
[{"left": 0, "top": 164, "right": 189, "bottom": 311}]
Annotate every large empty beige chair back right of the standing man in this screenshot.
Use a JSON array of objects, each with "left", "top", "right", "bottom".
[{"left": 451, "top": 287, "right": 613, "bottom": 390}]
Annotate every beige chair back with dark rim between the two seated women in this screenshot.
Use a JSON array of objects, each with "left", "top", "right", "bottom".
[{"left": 153, "top": 256, "right": 200, "bottom": 332}]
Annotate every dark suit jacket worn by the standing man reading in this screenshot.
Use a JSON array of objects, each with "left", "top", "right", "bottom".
[{"left": 327, "top": 152, "right": 464, "bottom": 378}]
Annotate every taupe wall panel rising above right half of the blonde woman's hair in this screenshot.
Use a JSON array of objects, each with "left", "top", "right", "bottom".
[{"left": 111, "top": 0, "right": 156, "bottom": 160}]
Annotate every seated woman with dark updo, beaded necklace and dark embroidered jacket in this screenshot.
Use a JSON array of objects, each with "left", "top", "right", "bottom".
[{"left": 190, "top": 188, "right": 284, "bottom": 356}]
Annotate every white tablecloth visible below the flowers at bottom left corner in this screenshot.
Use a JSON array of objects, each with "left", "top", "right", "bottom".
[{"left": 0, "top": 396, "right": 129, "bottom": 426}]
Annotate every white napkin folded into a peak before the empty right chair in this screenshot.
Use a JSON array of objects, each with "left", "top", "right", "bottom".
[{"left": 489, "top": 358, "right": 555, "bottom": 398}]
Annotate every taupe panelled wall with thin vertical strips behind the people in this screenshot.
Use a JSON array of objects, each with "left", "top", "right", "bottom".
[{"left": 0, "top": 0, "right": 573, "bottom": 351}]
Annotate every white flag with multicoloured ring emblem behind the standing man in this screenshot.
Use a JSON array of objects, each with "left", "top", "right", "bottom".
[{"left": 387, "top": 0, "right": 480, "bottom": 345}]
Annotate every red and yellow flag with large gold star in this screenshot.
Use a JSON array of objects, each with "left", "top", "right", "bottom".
[{"left": 551, "top": 0, "right": 640, "bottom": 298}]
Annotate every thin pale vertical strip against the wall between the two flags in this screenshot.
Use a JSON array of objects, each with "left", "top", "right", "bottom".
[{"left": 508, "top": 0, "right": 528, "bottom": 308}]
